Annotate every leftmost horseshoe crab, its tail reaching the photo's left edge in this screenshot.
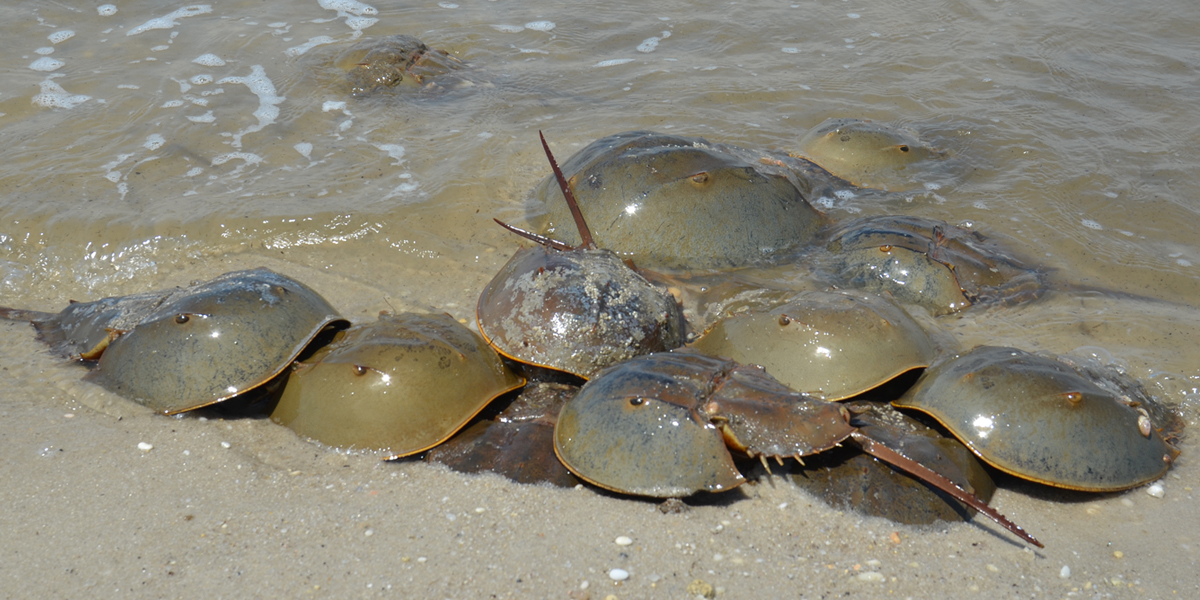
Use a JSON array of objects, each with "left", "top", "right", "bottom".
[{"left": 0, "top": 269, "right": 348, "bottom": 414}]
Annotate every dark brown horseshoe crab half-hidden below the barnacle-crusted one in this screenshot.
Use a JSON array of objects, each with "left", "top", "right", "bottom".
[{"left": 425, "top": 382, "right": 580, "bottom": 487}]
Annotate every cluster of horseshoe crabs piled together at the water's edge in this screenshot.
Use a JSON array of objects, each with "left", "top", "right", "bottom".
[{"left": 0, "top": 126, "right": 1178, "bottom": 546}]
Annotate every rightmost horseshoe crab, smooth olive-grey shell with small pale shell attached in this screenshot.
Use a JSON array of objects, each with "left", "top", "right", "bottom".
[{"left": 893, "top": 346, "right": 1180, "bottom": 492}]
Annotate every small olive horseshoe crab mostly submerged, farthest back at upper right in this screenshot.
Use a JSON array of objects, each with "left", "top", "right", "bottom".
[{"left": 798, "top": 119, "right": 946, "bottom": 191}]
